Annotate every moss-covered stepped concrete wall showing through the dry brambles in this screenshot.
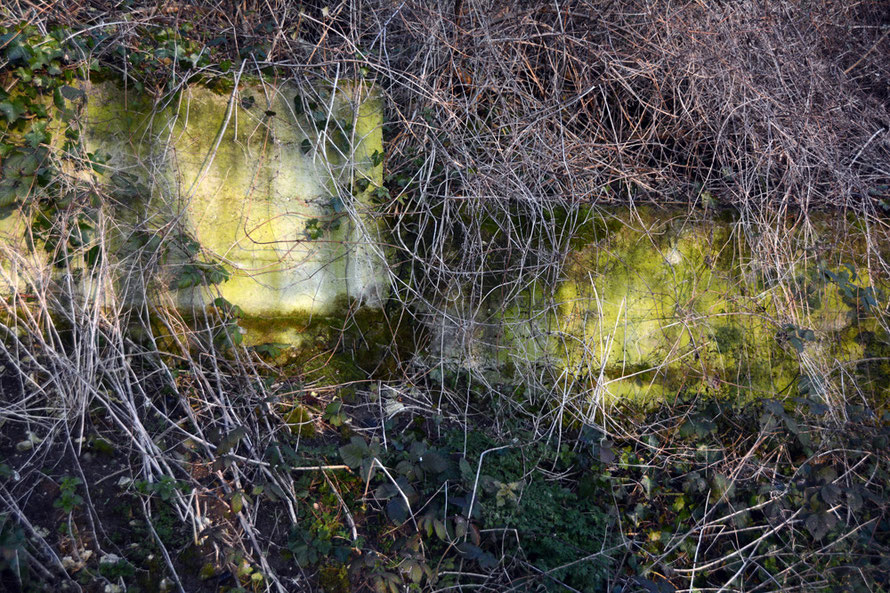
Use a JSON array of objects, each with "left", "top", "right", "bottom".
[{"left": 0, "top": 80, "right": 890, "bottom": 399}]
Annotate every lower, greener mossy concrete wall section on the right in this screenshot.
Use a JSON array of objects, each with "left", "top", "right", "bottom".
[{"left": 432, "top": 210, "right": 888, "bottom": 401}]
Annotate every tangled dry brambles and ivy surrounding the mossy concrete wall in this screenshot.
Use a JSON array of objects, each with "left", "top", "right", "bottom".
[{"left": 0, "top": 0, "right": 890, "bottom": 592}]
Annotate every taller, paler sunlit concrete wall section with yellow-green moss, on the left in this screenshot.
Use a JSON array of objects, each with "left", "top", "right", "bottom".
[{"left": 79, "top": 82, "right": 388, "bottom": 317}]
